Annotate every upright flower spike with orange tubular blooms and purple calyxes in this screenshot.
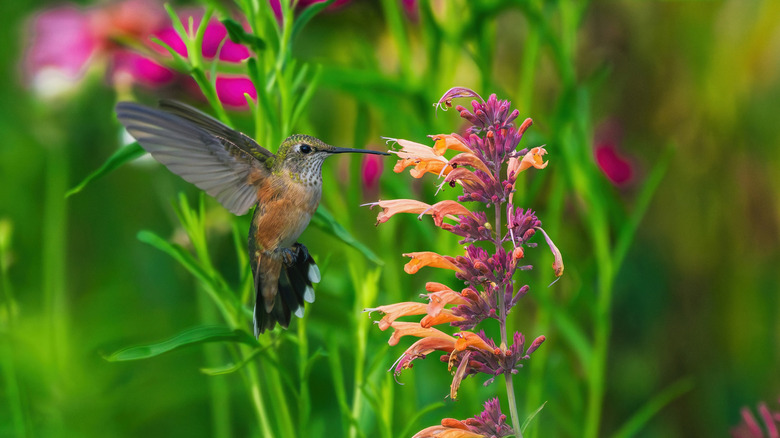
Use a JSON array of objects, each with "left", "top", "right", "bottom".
[{"left": 366, "top": 87, "right": 563, "bottom": 437}]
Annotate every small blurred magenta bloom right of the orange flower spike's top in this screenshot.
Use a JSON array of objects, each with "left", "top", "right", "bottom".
[{"left": 593, "top": 120, "right": 634, "bottom": 186}]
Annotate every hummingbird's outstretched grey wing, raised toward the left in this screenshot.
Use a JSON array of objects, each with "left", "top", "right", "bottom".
[{"left": 116, "top": 101, "right": 274, "bottom": 215}]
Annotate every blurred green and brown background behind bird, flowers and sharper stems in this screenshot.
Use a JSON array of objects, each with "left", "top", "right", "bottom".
[{"left": 0, "top": 0, "right": 780, "bottom": 437}]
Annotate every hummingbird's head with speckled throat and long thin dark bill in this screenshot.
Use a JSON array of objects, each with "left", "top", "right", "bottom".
[{"left": 274, "top": 134, "right": 390, "bottom": 185}]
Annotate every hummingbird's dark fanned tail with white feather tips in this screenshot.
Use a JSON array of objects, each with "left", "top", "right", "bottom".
[{"left": 254, "top": 243, "right": 320, "bottom": 336}]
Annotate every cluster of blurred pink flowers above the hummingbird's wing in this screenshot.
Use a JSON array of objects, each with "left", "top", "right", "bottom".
[{"left": 24, "top": 0, "right": 257, "bottom": 107}]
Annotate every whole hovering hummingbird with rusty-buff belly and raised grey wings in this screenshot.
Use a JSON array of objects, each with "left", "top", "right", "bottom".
[{"left": 116, "top": 100, "right": 389, "bottom": 337}]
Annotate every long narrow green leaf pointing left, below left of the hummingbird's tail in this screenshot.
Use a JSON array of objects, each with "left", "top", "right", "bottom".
[{"left": 104, "top": 326, "right": 260, "bottom": 362}]
